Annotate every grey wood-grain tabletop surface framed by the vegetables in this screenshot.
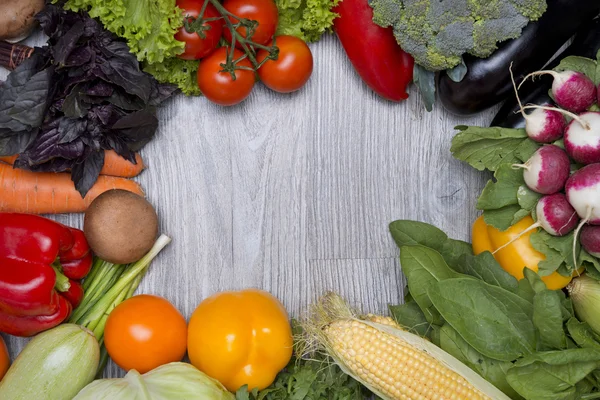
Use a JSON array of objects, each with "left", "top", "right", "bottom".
[{"left": 0, "top": 35, "right": 493, "bottom": 376}]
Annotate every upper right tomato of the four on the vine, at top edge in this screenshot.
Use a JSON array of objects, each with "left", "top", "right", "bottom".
[{"left": 223, "top": 0, "right": 279, "bottom": 48}]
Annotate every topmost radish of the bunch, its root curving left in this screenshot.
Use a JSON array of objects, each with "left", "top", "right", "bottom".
[{"left": 519, "top": 70, "right": 598, "bottom": 113}]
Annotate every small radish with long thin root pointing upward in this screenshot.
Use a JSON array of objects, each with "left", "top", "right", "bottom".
[{"left": 509, "top": 63, "right": 567, "bottom": 143}]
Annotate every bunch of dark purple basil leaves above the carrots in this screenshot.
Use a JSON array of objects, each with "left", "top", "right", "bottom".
[{"left": 0, "top": 5, "right": 175, "bottom": 197}]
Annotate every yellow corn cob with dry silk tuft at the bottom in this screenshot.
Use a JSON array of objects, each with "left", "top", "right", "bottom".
[{"left": 302, "top": 294, "right": 510, "bottom": 400}]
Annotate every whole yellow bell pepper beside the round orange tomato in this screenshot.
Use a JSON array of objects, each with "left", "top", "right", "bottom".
[{"left": 188, "top": 289, "right": 293, "bottom": 392}]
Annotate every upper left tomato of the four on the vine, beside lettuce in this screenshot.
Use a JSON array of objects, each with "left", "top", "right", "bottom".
[{"left": 175, "top": 0, "right": 223, "bottom": 60}]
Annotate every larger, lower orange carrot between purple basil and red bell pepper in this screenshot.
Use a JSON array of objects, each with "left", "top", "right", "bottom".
[{"left": 0, "top": 163, "right": 144, "bottom": 214}]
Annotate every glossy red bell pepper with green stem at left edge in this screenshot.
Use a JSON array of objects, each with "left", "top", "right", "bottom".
[{"left": 0, "top": 213, "right": 92, "bottom": 336}]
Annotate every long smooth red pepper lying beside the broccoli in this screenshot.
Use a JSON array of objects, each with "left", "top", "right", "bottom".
[{"left": 333, "top": 0, "right": 414, "bottom": 101}]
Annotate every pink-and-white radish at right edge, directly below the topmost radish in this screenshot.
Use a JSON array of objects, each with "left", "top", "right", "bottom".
[{"left": 565, "top": 112, "right": 600, "bottom": 164}]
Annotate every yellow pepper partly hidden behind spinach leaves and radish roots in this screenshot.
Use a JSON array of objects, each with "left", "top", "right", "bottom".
[{"left": 472, "top": 215, "right": 573, "bottom": 290}]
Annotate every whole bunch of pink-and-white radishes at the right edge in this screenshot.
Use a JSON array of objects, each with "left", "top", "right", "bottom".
[{"left": 511, "top": 66, "right": 600, "bottom": 267}]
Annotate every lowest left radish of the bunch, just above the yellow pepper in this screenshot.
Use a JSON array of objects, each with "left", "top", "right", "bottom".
[{"left": 534, "top": 193, "right": 579, "bottom": 236}]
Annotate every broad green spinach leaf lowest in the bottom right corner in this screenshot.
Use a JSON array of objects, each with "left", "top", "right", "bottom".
[{"left": 506, "top": 349, "right": 600, "bottom": 400}]
